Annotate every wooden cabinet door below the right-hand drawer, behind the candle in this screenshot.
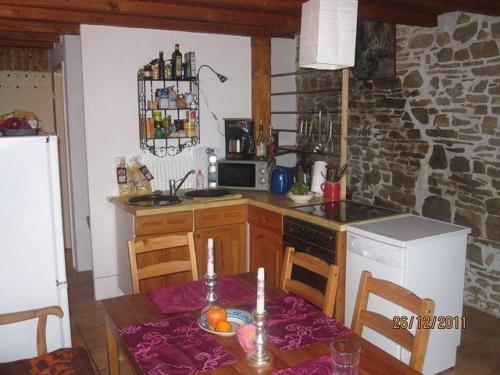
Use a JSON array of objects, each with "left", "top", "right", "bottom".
[{"left": 194, "top": 224, "right": 246, "bottom": 278}]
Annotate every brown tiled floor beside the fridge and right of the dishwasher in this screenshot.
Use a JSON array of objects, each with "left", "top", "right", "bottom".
[{"left": 67, "top": 254, "right": 500, "bottom": 375}]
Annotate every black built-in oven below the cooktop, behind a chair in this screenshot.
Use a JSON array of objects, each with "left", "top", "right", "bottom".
[{"left": 283, "top": 216, "right": 337, "bottom": 293}]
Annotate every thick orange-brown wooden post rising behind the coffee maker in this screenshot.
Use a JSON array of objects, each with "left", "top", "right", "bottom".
[{"left": 252, "top": 37, "right": 271, "bottom": 139}]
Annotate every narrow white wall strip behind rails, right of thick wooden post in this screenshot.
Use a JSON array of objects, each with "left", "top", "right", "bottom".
[{"left": 271, "top": 38, "right": 297, "bottom": 167}]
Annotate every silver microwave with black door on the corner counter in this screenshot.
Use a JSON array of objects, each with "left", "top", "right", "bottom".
[{"left": 217, "top": 159, "right": 269, "bottom": 190}]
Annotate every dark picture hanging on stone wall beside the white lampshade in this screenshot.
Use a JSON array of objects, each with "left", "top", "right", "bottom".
[{"left": 354, "top": 20, "right": 396, "bottom": 81}]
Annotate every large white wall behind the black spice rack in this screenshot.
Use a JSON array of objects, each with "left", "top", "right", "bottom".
[{"left": 81, "top": 25, "right": 251, "bottom": 299}]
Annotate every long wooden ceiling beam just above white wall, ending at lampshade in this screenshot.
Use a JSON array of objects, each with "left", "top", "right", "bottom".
[{"left": 0, "top": 5, "right": 294, "bottom": 36}]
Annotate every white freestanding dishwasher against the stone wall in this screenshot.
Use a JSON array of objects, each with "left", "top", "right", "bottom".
[{"left": 345, "top": 216, "right": 470, "bottom": 375}]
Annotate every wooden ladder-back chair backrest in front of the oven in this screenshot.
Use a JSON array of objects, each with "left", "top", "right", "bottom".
[{"left": 281, "top": 247, "right": 339, "bottom": 317}]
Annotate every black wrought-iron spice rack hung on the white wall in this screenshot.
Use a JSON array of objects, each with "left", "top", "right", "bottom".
[{"left": 137, "top": 76, "right": 200, "bottom": 157}]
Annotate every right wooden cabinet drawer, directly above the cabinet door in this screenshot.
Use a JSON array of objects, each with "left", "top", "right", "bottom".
[{"left": 194, "top": 205, "right": 247, "bottom": 229}]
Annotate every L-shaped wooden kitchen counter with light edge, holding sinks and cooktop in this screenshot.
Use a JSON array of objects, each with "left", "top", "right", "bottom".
[{"left": 108, "top": 190, "right": 407, "bottom": 232}]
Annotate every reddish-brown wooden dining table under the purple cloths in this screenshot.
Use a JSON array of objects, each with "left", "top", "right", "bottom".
[{"left": 103, "top": 272, "right": 419, "bottom": 375}]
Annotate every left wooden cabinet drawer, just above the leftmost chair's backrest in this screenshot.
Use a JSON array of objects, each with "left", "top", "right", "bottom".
[{"left": 135, "top": 211, "right": 193, "bottom": 236}]
